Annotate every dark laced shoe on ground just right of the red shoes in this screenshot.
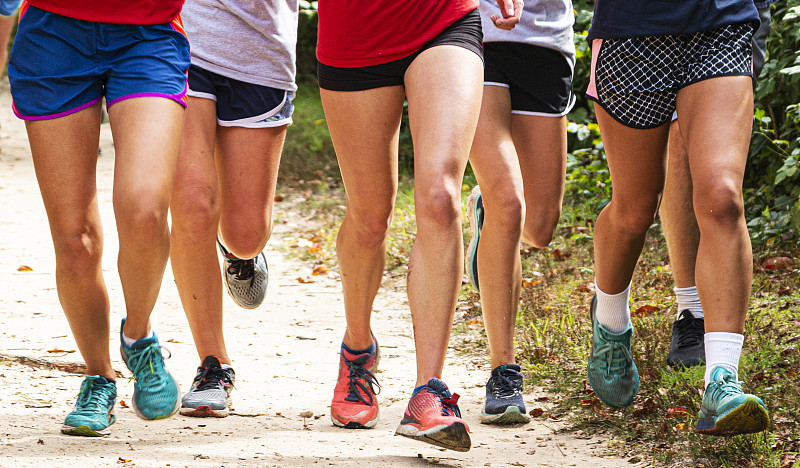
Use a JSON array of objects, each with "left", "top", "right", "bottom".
[{"left": 481, "top": 364, "right": 531, "bottom": 424}]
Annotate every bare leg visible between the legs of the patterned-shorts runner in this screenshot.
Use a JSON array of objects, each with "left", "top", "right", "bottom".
[{"left": 659, "top": 121, "right": 700, "bottom": 288}]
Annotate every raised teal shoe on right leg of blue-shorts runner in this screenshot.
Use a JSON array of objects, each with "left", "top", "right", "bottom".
[{"left": 119, "top": 319, "right": 181, "bottom": 419}]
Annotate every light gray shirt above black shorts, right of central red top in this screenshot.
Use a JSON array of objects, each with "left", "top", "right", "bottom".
[{"left": 480, "top": 0, "right": 575, "bottom": 67}]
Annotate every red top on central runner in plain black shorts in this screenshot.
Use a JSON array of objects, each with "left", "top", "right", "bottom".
[{"left": 317, "top": 0, "right": 478, "bottom": 68}]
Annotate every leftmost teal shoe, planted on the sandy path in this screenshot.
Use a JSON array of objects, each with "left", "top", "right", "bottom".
[{"left": 61, "top": 375, "right": 117, "bottom": 437}]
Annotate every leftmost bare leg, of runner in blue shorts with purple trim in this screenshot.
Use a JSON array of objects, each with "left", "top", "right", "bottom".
[{"left": 26, "top": 104, "right": 116, "bottom": 379}]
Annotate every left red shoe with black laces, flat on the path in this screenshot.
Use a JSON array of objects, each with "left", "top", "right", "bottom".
[{"left": 331, "top": 337, "right": 381, "bottom": 429}]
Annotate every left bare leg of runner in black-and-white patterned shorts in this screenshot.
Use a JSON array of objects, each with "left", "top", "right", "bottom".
[{"left": 594, "top": 106, "right": 669, "bottom": 294}]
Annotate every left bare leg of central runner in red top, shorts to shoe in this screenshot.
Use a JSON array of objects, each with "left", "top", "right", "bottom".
[{"left": 320, "top": 86, "right": 404, "bottom": 349}]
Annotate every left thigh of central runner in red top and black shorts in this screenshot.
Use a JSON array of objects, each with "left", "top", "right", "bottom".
[{"left": 320, "top": 86, "right": 404, "bottom": 218}]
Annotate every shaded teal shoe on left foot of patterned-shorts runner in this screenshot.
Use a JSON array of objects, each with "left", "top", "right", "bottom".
[{"left": 588, "top": 296, "right": 639, "bottom": 407}]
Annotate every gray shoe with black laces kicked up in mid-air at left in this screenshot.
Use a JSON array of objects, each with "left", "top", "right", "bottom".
[{"left": 217, "top": 239, "right": 269, "bottom": 309}]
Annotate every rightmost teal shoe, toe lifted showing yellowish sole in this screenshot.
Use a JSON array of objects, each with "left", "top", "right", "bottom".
[{"left": 694, "top": 367, "right": 769, "bottom": 436}]
